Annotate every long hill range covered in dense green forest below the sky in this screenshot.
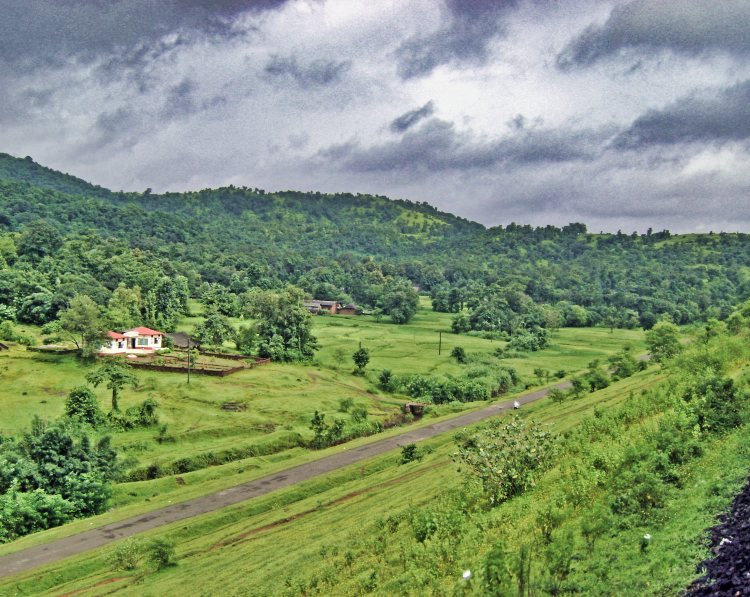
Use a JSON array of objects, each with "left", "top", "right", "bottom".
[{"left": 0, "top": 154, "right": 750, "bottom": 329}]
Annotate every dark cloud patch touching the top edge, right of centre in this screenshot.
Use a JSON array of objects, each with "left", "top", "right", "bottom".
[{"left": 396, "top": 0, "right": 516, "bottom": 79}]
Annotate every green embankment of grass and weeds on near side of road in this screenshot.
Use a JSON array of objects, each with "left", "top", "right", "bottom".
[{"left": 0, "top": 312, "right": 750, "bottom": 595}]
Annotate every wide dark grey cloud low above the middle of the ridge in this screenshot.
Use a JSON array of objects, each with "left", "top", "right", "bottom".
[{"left": 320, "top": 118, "right": 610, "bottom": 172}]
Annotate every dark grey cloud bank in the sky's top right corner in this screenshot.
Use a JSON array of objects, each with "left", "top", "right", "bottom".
[{"left": 557, "top": 0, "right": 750, "bottom": 69}]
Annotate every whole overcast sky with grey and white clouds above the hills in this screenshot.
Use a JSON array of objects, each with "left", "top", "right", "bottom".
[{"left": 0, "top": 0, "right": 750, "bottom": 233}]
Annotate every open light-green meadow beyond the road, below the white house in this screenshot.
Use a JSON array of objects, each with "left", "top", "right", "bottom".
[{"left": 0, "top": 305, "right": 643, "bottom": 484}]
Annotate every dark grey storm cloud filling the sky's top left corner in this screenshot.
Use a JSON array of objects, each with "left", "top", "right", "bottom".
[{"left": 0, "top": 0, "right": 287, "bottom": 71}]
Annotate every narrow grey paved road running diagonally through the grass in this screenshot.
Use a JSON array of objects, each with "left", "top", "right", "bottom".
[{"left": 0, "top": 382, "right": 570, "bottom": 578}]
